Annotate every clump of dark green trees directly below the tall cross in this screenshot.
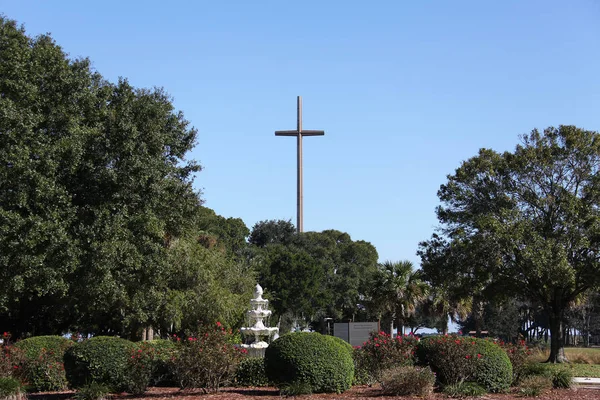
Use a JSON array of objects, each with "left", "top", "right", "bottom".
[{"left": 250, "top": 225, "right": 377, "bottom": 321}]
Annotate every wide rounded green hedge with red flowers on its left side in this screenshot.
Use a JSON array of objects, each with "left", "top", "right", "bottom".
[{"left": 417, "top": 335, "right": 512, "bottom": 392}]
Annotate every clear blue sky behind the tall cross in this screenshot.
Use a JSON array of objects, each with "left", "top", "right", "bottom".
[{"left": 0, "top": 0, "right": 600, "bottom": 264}]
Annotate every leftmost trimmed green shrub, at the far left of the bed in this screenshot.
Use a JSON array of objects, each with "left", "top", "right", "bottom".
[{"left": 15, "top": 336, "right": 74, "bottom": 392}]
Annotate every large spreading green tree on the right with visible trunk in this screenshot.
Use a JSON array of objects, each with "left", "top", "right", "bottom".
[{"left": 421, "top": 126, "right": 600, "bottom": 362}]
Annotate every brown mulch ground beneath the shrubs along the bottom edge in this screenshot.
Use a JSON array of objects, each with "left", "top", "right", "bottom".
[{"left": 28, "top": 386, "right": 600, "bottom": 400}]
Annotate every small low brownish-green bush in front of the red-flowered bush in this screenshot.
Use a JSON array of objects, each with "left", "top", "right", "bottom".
[{"left": 381, "top": 366, "right": 435, "bottom": 397}]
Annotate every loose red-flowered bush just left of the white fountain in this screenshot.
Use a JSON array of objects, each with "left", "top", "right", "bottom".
[{"left": 173, "top": 322, "right": 247, "bottom": 393}]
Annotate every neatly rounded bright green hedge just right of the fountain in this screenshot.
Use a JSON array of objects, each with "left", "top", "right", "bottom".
[{"left": 265, "top": 332, "right": 354, "bottom": 393}]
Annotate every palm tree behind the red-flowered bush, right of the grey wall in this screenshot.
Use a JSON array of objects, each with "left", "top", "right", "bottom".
[{"left": 371, "top": 261, "right": 429, "bottom": 334}]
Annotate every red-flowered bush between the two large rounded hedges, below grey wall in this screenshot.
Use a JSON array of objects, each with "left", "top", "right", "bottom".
[{"left": 354, "top": 332, "right": 419, "bottom": 381}]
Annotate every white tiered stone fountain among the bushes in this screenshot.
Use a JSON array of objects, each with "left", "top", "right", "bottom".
[{"left": 240, "top": 283, "right": 279, "bottom": 357}]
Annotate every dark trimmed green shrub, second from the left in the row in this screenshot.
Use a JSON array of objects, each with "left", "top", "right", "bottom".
[{"left": 65, "top": 336, "right": 135, "bottom": 392}]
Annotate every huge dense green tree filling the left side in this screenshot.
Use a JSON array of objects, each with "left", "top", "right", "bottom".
[{"left": 0, "top": 17, "right": 200, "bottom": 336}]
